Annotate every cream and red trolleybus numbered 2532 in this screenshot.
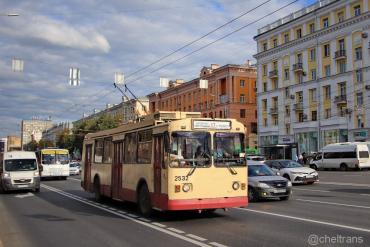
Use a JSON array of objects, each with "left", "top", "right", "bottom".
[{"left": 81, "top": 111, "right": 248, "bottom": 215}]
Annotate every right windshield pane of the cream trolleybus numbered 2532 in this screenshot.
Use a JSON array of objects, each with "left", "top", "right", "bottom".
[{"left": 214, "top": 133, "right": 246, "bottom": 166}]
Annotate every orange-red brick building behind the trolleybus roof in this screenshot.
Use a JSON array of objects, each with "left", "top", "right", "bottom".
[{"left": 148, "top": 62, "right": 257, "bottom": 147}]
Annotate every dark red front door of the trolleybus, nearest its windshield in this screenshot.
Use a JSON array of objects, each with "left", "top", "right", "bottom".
[{"left": 154, "top": 135, "right": 163, "bottom": 195}]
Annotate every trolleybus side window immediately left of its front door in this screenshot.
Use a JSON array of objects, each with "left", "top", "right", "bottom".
[{"left": 137, "top": 129, "right": 152, "bottom": 164}]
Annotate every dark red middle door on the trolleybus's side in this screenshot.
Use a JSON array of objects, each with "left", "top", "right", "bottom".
[{"left": 111, "top": 141, "right": 123, "bottom": 199}]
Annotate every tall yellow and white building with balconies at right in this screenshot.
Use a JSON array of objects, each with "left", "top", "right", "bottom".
[{"left": 255, "top": 0, "right": 370, "bottom": 157}]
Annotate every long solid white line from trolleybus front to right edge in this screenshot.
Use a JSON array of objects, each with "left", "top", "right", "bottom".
[{"left": 235, "top": 208, "right": 370, "bottom": 233}]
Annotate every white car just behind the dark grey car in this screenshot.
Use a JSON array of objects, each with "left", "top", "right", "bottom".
[{"left": 265, "top": 160, "right": 319, "bottom": 184}]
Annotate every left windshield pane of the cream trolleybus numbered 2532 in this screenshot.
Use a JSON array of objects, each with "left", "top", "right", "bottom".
[{"left": 170, "top": 131, "right": 211, "bottom": 167}]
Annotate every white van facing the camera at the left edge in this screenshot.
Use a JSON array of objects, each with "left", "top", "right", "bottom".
[{"left": 0, "top": 151, "right": 40, "bottom": 192}]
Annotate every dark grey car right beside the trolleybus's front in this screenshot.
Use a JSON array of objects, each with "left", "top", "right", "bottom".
[{"left": 248, "top": 164, "right": 292, "bottom": 202}]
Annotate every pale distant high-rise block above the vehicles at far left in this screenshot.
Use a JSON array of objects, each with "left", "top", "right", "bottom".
[{"left": 21, "top": 119, "right": 53, "bottom": 149}]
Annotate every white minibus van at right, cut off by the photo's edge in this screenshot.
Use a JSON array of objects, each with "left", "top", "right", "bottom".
[{"left": 310, "top": 142, "right": 370, "bottom": 171}]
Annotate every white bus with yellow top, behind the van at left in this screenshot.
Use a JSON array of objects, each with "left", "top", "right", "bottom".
[{"left": 36, "top": 148, "right": 69, "bottom": 180}]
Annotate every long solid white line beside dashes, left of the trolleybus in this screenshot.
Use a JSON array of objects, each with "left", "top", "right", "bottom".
[{"left": 41, "top": 184, "right": 211, "bottom": 247}]
